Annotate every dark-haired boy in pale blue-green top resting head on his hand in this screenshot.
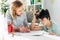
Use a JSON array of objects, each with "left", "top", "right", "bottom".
[{"left": 31, "top": 9, "right": 60, "bottom": 36}]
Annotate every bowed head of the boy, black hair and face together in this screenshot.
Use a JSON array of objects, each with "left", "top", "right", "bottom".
[{"left": 36, "top": 9, "right": 50, "bottom": 25}]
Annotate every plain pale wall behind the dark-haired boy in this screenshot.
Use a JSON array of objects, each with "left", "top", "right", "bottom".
[{"left": 43, "top": 0, "right": 60, "bottom": 26}]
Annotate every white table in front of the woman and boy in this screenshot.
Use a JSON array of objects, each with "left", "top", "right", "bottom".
[{"left": 5, "top": 31, "right": 60, "bottom": 40}]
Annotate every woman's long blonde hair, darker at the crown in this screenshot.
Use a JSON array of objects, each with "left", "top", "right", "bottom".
[{"left": 10, "top": 0, "right": 23, "bottom": 19}]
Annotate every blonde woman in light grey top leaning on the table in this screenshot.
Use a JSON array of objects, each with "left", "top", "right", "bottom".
[{"left": 6, "top": 1, "right": 29, "bottom": 32}]
